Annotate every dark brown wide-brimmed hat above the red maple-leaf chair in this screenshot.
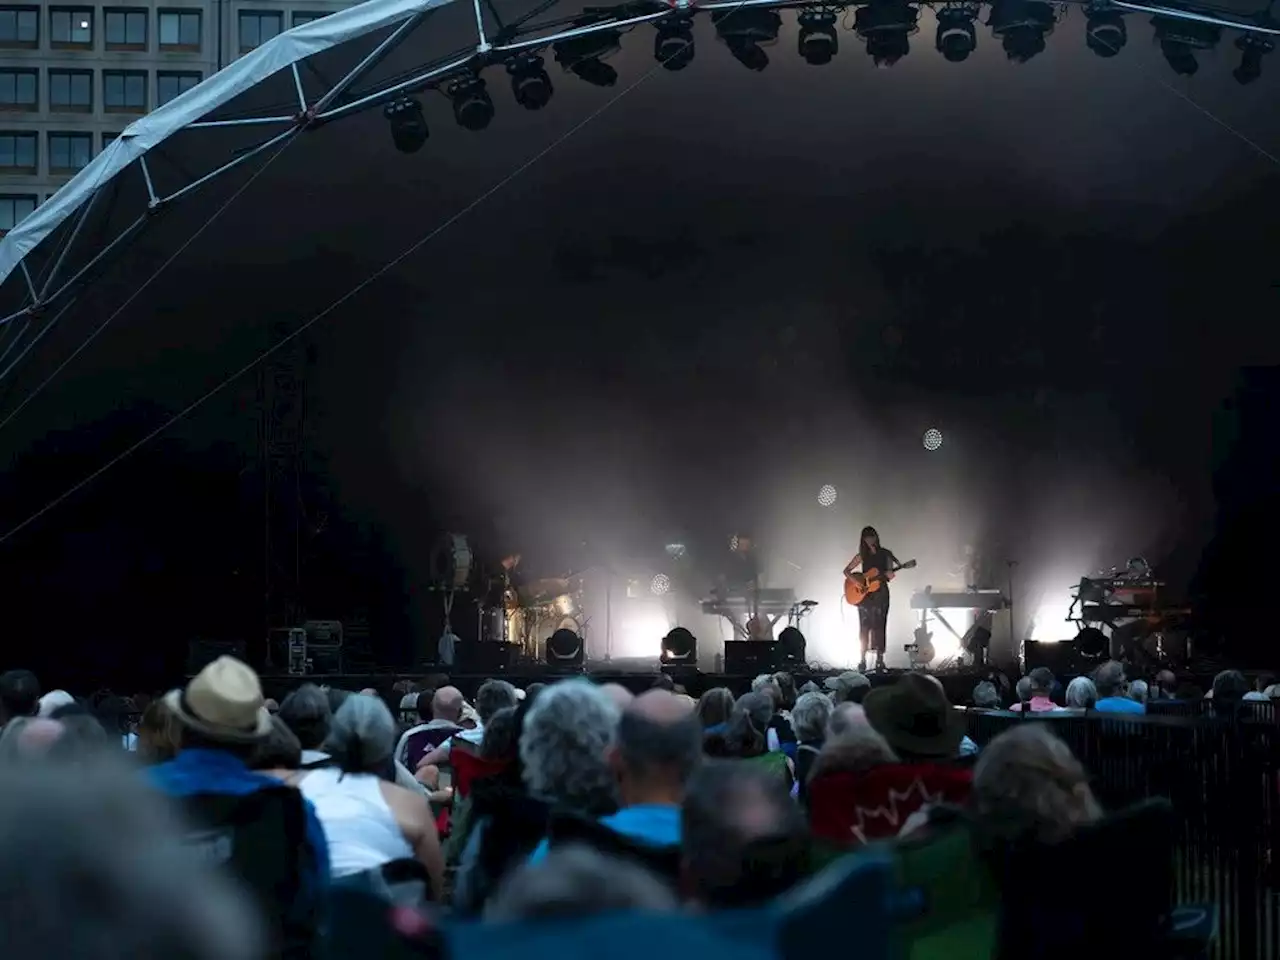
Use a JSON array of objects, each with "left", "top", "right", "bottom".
[{"left": 863, "top": 673, "right": 965, "bottom": 760}]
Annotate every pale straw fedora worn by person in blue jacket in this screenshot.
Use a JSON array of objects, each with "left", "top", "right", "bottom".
[{"left": 164, "top": 657, "right": 271, "bottom": 744}]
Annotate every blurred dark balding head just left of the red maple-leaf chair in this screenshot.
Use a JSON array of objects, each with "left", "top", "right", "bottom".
[{"left": 681, "top": 760, "right": 808, "bottom": 909}]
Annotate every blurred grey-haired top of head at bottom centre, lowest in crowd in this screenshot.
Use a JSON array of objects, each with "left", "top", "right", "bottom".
[{"left": 485, "top": 844, "right": 677, "bottom": 923}]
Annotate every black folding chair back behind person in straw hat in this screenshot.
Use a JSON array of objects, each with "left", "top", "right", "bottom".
[{"left": 182, "top": 786, "right": 321, "bottom": 957}]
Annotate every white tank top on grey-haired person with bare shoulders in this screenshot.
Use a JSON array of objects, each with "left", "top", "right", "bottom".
[{"left": 298, "top": 767, "right": 413, "bottom": 877}]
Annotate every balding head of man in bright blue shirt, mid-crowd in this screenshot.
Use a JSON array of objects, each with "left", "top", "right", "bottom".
[{"left": 609, "top": 690, "right": 703, "bottom": 806}]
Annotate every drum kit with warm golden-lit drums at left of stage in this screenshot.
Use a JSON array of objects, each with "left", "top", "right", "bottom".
[{"left": 431, "top": 534, "right": 586, "bottom": 659}]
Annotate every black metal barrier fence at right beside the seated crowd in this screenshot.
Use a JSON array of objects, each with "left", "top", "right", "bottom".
[{"left": 968, "top": 704, "right": 1280, "bottom": 960}]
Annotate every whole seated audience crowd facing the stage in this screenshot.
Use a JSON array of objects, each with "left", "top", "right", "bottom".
[{"left": 0, "top": 657, "right": 1249, "bottom": 960}]
